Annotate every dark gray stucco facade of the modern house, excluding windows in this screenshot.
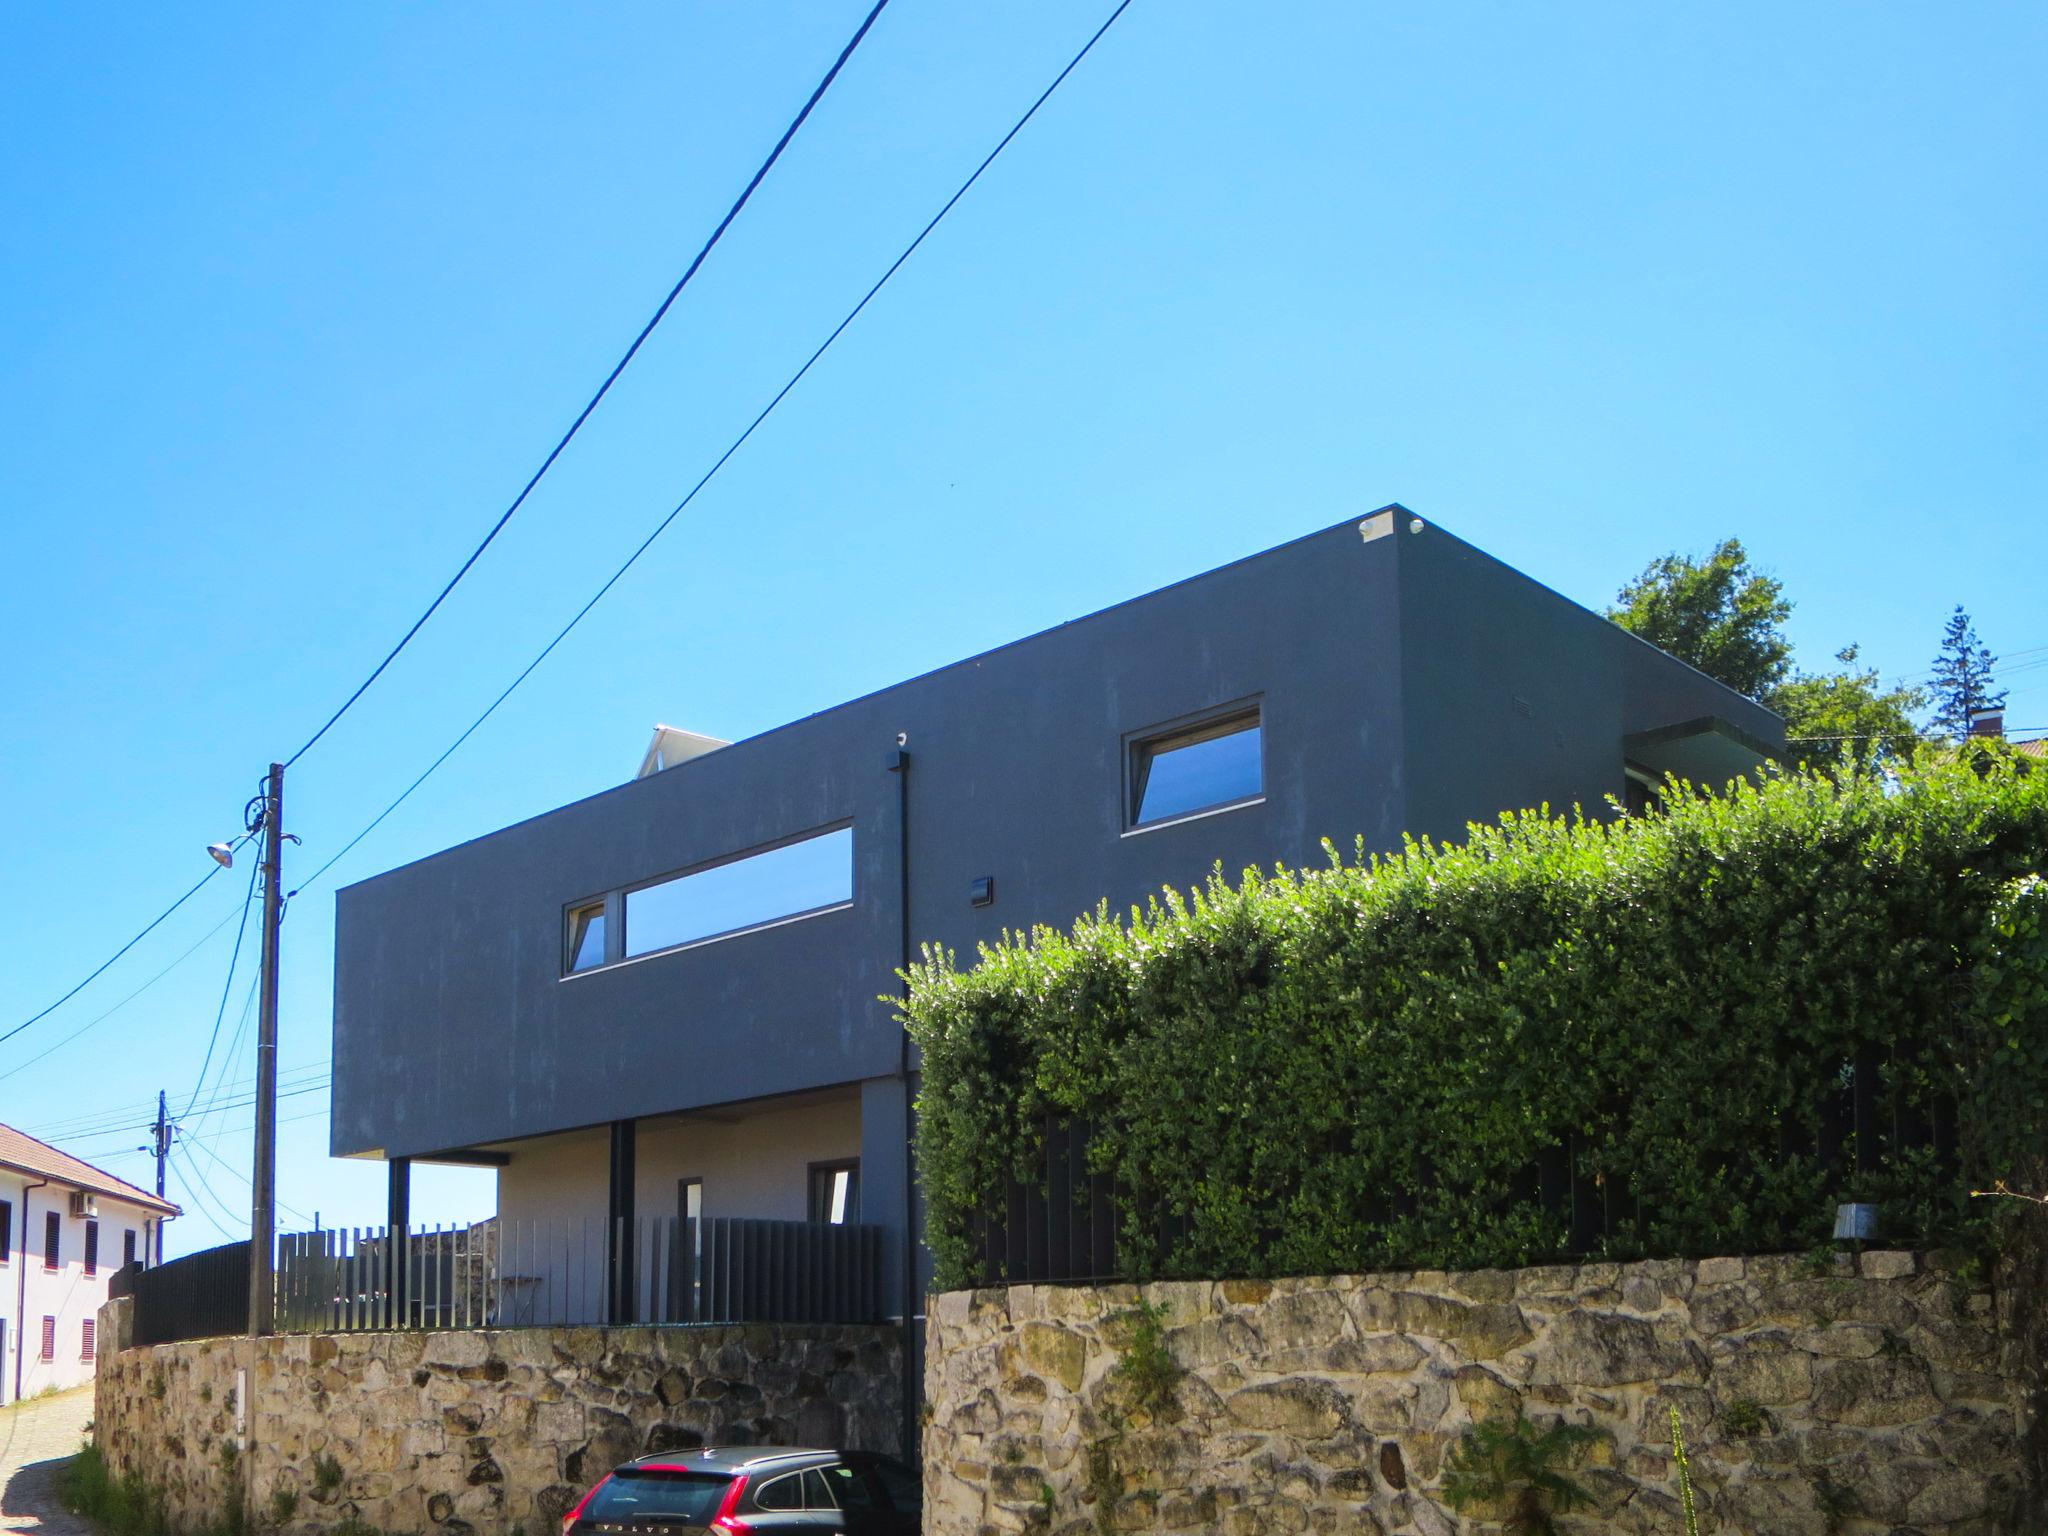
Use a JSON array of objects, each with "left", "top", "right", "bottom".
[{"left": 332, "top": 508, "right": 1784, "bottom": 1318}]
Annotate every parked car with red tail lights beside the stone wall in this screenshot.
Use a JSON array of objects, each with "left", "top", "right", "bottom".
[{"left": 561, "top": 1446, "right": 924, "bottom": 1536}]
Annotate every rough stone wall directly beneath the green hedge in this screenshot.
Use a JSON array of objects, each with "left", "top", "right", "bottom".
[{"left": 924, "top": 1253, "right": 2019, "bottom": 1536}]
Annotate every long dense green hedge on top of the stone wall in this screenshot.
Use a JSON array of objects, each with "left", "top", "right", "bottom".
[{"left": 903, "top": 756, "right": 2048, "bottom": 1288}]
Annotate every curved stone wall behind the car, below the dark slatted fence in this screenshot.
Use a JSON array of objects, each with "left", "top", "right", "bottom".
[{"left": 94, "top": 1309, "right": 901, "bottom": 1536}]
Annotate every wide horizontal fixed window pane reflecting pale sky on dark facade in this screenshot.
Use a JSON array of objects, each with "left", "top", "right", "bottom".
[{"left": 625, "top": 827, "right": 854, "bottom": 961}]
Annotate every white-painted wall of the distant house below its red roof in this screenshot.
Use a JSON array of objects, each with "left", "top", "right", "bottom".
[{"left": 0, "top": 1174, "right": 150, "bottom": 1403}]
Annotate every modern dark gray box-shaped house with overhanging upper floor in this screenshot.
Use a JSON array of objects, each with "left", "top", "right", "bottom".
[{"left": 334, "top": 506, "right": 1784, "bottom": 1343}]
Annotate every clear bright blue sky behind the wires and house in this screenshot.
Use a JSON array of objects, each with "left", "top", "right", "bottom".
[{"left": 0, "top": 0, "right": 2048, "bottom": 1251}]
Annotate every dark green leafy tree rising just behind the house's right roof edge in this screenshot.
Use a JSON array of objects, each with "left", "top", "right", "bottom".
[{"left": 1608, "top": 539, "right": 1792, "bottom": 700}]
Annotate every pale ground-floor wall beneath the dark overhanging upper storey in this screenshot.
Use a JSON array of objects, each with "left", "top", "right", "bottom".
[{"left": 498, "top": 1092, "right": 860, "bottom": 1323}]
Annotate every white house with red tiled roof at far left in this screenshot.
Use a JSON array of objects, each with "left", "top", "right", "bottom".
[{"left": 0, "top": 1124, "right": 178, "bottom": 1403}]
